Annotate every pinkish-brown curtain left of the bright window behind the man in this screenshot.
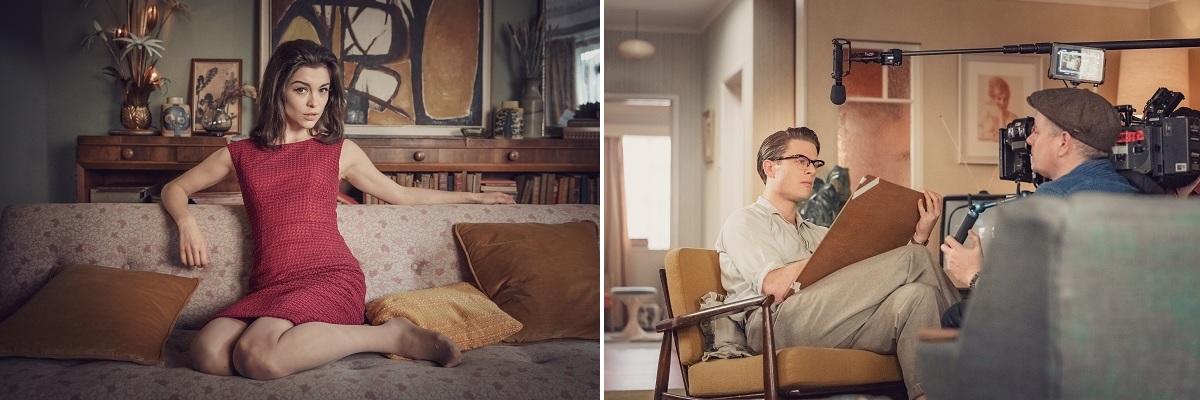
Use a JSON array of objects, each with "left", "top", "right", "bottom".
[{"left": 602, "top": 137, "right": 630, "bottom": 289}]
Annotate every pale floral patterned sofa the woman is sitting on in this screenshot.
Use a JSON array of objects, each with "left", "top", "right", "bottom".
[{"left": 0, "top": 204, "right": 600, "bottom": 399}]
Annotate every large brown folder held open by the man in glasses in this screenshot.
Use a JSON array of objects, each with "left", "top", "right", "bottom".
[{"left": 796, "top": 175, "right": 925, "bottom": 289}]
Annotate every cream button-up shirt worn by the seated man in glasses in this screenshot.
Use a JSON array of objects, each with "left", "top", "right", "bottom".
[{"left": 716, "top": 196, "right": 829, "bottom": 322}]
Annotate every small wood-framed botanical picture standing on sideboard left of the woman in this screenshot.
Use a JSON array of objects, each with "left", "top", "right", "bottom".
[{"left": 188, "top": 59, "right": 242, "bottom": 136}]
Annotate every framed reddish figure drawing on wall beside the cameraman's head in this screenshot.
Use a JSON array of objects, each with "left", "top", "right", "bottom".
[{"left": 959, "top": 54, "right": 1045, "bottom": 165}]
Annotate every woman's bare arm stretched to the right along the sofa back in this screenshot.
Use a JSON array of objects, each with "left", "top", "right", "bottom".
[{"left": 340, "top": 139, "right": 515, "bottom": 204}]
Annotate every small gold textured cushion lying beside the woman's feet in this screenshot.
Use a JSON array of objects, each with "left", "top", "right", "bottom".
[{"left": 367, "top": 282, "right": 521, "bottom": 359}]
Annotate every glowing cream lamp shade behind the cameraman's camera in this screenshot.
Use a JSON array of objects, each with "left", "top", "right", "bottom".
[{"left": 1117, "top": 48, "right": 1190, "bottom": 110}]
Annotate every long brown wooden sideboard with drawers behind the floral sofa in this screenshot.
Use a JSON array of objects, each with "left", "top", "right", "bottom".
[{"left": 76, "top": 136, "right": 600, "bottom": 203}]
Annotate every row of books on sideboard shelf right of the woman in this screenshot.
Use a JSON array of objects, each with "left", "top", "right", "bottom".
[{"left": 355, "top": 172, "right": 600, "bottom": 204}]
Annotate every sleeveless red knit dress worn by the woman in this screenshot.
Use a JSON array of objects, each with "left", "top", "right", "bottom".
[{"left": 217, "top": 139, "right": 366, "bottom": 324}]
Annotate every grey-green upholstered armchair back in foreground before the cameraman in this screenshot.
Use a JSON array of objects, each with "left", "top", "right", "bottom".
[{"left": 918, "top": 193, "right": 1200, "bottom": 400}]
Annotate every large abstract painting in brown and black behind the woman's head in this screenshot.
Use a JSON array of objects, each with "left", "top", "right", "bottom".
[{"left": 257, "top": 0, "right": 492, "bottom": 136}]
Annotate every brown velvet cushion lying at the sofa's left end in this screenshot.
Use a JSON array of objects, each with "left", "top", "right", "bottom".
[{"left": 0, "top": 264, "right": 199, "bottom": 365}]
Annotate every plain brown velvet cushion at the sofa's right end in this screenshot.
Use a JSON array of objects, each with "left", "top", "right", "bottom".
[{"left": 455, "top": 221, "right": 600, "bottom": 342}]
